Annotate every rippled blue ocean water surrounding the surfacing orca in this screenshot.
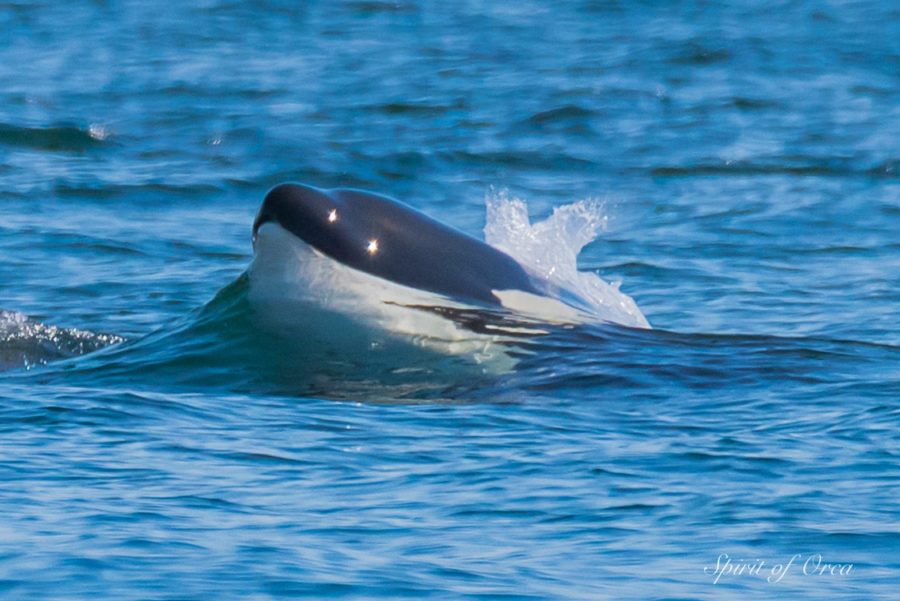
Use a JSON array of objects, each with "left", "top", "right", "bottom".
[{"left": 0, "top": 0, "right": 900, "bottom": 600}]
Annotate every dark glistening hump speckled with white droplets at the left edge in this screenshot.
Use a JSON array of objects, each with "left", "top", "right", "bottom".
[{"left": 0, "top": 311, "right": 124, "bottom": 371}]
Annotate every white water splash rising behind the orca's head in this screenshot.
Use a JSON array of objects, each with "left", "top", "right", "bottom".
[{"left": 484, "top": 190, "right": 650, "bottom": 328}]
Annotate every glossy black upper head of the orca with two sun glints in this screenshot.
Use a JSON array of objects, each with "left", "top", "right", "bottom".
[{"left": 253, "top": 184, "right": 541, "bottom": 304}]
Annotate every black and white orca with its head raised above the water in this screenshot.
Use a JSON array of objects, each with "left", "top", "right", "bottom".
[{"left": 248, "top": 184, "right": 648, "bottom": 354}]
